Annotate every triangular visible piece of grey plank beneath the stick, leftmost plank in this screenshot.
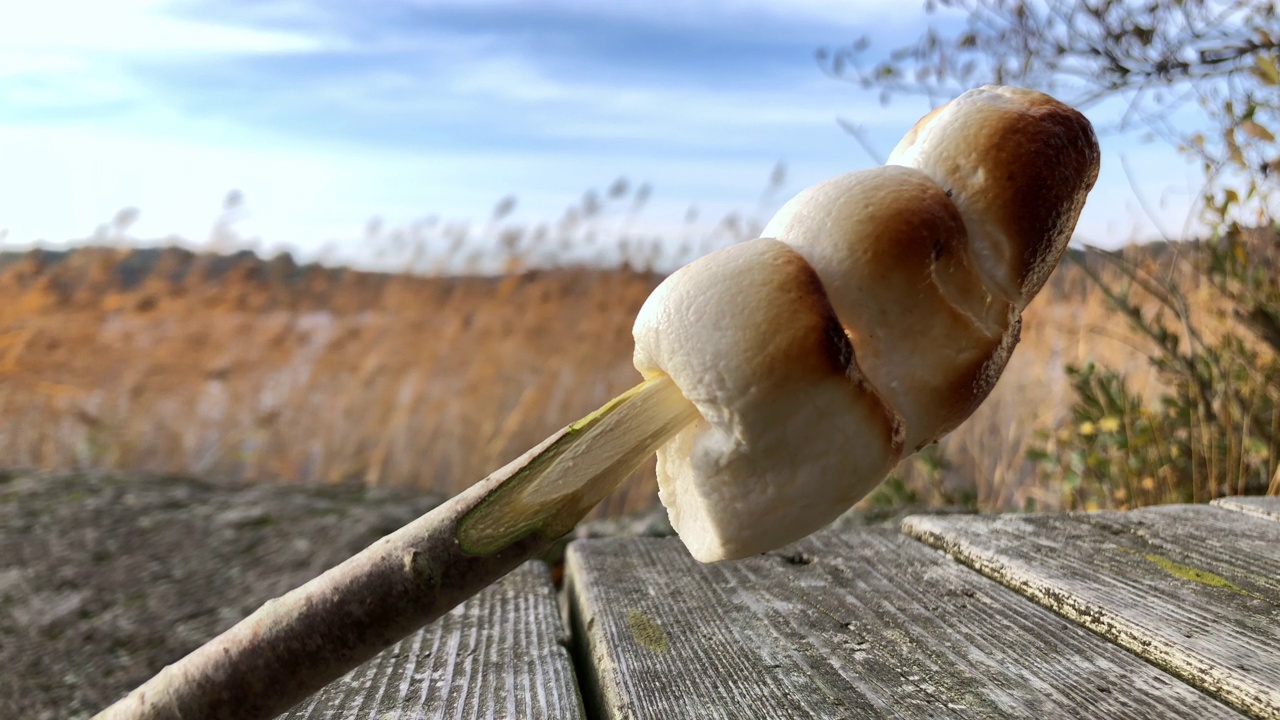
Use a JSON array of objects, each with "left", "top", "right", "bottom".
[{"left": 282, "top": 562, "right": 584, "bottom": 720}]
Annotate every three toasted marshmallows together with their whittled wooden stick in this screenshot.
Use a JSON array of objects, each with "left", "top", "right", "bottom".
[{"left": 97, "top": 87, "right": 1098, "bottom": 720}]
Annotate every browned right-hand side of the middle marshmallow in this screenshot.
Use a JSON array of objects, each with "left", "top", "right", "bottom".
[{"left": 841, "top": 174, "right": 1010, "bottom": 443}]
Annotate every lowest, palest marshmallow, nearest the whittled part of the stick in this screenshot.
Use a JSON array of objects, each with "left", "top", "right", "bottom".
[{"left": 634, "top": 238, "right": 905, "bottom": 562}]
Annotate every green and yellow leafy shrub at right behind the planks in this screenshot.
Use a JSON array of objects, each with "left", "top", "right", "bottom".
[{"left": 1028, "top": 233, "right": 1280, "bottom": 509}]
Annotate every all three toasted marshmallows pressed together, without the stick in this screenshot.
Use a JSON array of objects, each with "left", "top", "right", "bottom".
[{"left": 635, "top": 86, "right": 1098, "bottom": 561}]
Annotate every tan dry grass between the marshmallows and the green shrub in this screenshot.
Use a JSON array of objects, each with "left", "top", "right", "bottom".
[{"left": 916, "top": 245, "right": 1275, "bottom": 510}]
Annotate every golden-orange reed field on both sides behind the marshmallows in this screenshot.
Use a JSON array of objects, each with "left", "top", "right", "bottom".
[{"left": 0, "top": 235, "right": 1239, "bottom": 515}]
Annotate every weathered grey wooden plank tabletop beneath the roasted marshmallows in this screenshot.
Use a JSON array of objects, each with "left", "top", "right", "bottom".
[{"left": 288, "top": 497, "right": 1280, "bottom": 720}]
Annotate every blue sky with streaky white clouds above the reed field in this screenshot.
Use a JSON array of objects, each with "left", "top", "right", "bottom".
[{"left": 0, "top": 0, "right": 1196, "bottom": 266}]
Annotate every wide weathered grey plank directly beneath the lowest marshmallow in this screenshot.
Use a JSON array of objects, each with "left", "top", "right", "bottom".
[{"left": 567, "top": 528, "right": 1240, "bottom": 720}]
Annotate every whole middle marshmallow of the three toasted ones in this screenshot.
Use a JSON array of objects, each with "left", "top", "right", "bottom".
[{"left": 765, "top": 167, "right": 1015, "bottom": 451}]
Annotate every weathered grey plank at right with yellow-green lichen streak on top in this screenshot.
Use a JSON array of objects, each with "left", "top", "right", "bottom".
[{"left": 902, "top": 505, "right": 1280, "bottom": 719}]
